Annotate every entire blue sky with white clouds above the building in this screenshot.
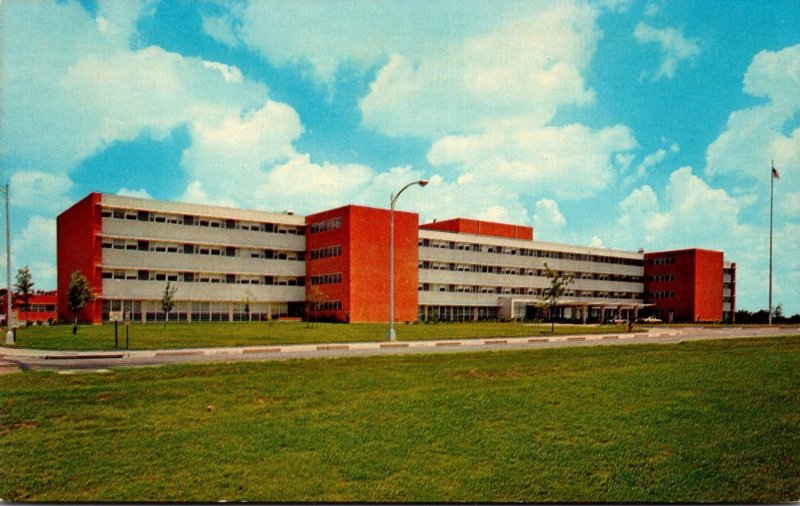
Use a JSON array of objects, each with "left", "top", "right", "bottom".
[{"left": 0, "top": 0, "right": 800, "bottom": 314}]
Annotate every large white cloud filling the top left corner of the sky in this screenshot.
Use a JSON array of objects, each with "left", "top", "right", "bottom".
[{"left": 0, "top": 1, "right": 267, "bottom": 172}]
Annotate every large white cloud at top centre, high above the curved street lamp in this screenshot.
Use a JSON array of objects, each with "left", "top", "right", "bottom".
[{"left": 359, "top": 2, "right": 600, "bottom": 138}]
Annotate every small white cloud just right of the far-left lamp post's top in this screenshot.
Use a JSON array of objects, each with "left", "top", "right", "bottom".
[{"left": 9, "top": 170, "right": 74, "bottom": 212}]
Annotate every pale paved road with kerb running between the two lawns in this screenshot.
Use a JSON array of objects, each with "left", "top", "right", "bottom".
[{"left": 0, "top": 326, "right": 800, "bottom": 374}]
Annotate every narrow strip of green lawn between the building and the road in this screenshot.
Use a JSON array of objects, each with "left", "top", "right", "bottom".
[{"left": 3, "top": 322, "right": 636, "bottom": 350}]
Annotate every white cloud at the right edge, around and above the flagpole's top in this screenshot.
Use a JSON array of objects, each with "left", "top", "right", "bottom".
[{"left": 706, "top": 45, "right": 800, "bottom": 188}]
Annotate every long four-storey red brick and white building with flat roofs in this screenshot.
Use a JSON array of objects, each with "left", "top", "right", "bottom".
[{"left": 57, "top": 193, "right": 736, "bottom": 323}]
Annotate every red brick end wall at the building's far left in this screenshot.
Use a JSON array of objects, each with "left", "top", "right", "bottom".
[{"left": 56, "top": 193, "right": 103, "bottom": 323}]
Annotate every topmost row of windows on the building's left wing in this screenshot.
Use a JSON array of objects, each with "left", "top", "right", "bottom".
[{"left": 101, "top": 208, "right": 305, "bottom": 235}]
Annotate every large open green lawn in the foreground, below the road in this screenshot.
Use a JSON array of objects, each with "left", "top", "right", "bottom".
[{"left": 0, "top": 337, "right": 800, "bottom": 503}]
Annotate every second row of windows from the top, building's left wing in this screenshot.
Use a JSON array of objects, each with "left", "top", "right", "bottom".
[{"left": 102, "top": 237, "right": 305, "bottom": 261}]
